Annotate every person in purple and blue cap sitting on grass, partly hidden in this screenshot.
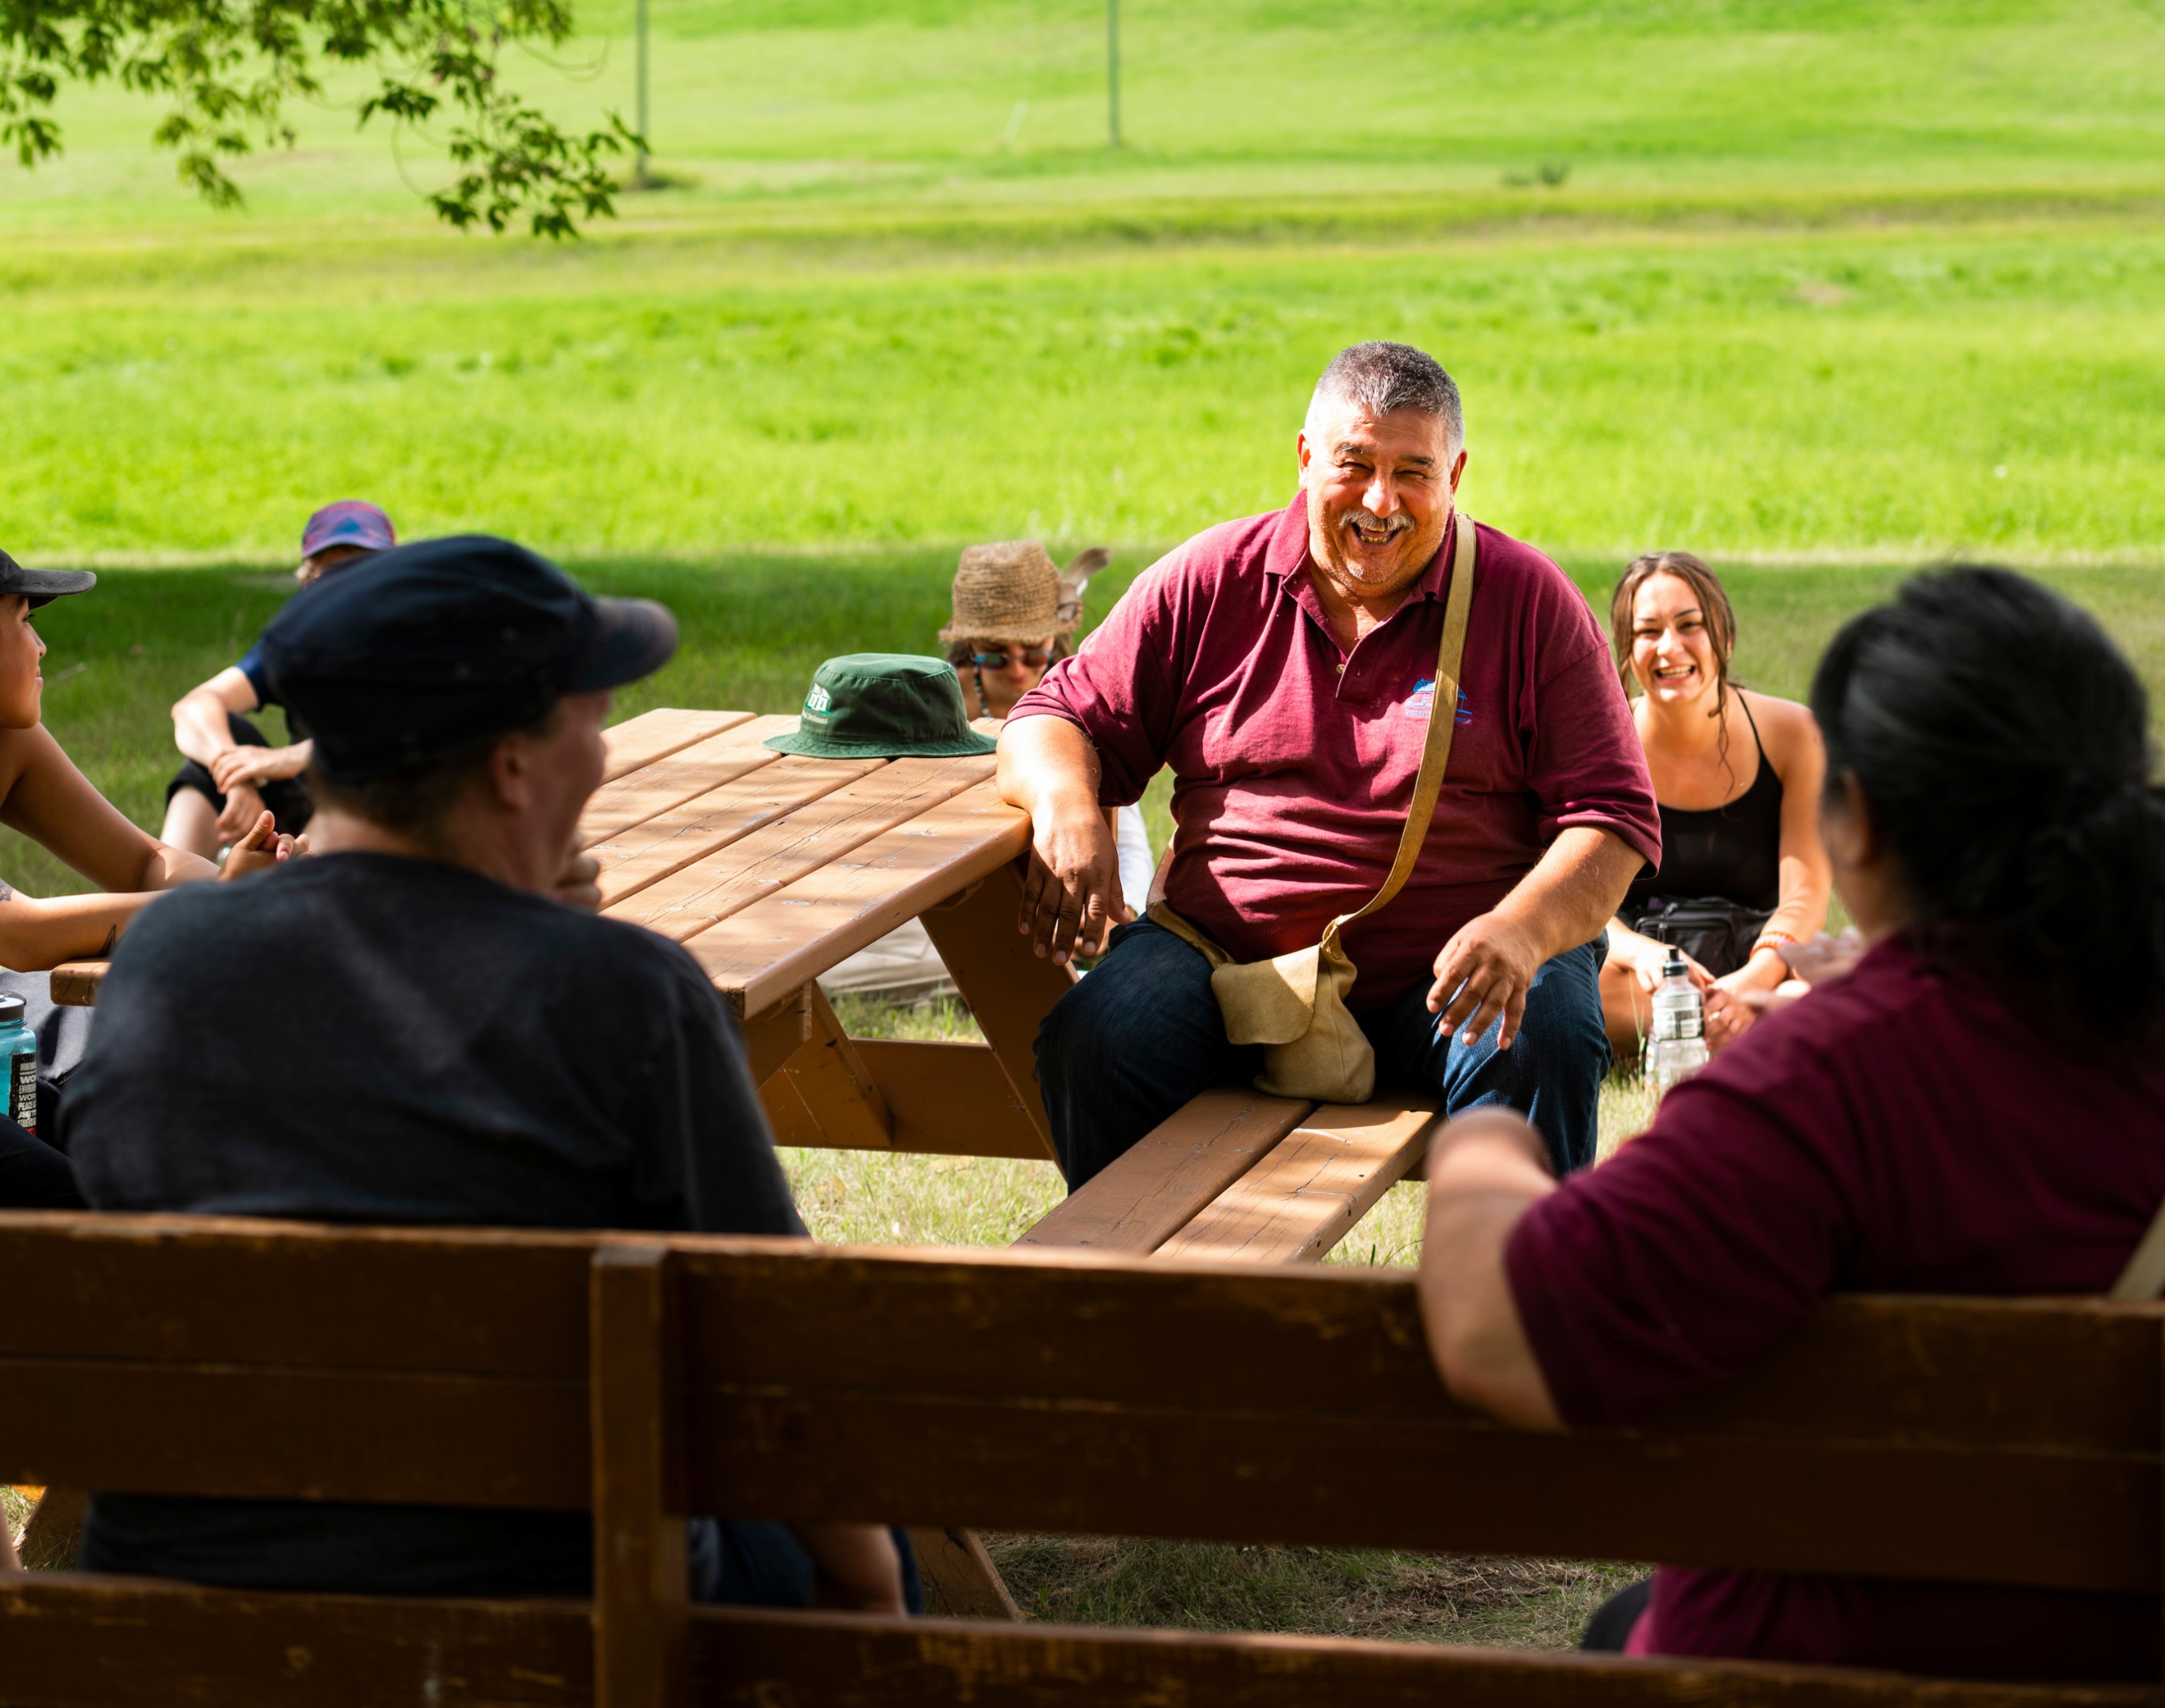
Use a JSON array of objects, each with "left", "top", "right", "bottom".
[{"left": 163, "top": 498, "right": 399, "bottom": 860}]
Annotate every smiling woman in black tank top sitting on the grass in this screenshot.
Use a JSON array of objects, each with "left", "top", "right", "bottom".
[{"left": 1602, "top": 552, "right": 1830, "bottom": 1058}]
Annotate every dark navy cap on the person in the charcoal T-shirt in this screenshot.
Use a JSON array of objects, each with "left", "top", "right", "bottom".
[{"left": 262, "top": 535, "right": 678, "bottom": 782}]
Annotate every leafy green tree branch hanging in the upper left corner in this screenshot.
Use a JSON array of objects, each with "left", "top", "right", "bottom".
[{"left": 0, "top": 0, "right": 639, "bottom": 238}]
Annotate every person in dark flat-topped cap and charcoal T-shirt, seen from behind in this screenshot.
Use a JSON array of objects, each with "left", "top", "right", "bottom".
[{"left": 65, "top": 539, "right": 922, "bottom": 1615}]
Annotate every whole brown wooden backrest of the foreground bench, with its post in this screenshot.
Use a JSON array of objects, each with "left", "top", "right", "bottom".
[{"left": 0, "top": 1212, "right": 2165, "bottom": 1708}]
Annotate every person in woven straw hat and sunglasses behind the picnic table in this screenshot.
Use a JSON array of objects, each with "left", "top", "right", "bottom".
[{"left": 814, "top": 539, "right": 1154, "bottom": 996}]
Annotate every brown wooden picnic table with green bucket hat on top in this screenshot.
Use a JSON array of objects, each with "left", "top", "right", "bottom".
[{"left": 52, "top": 710, "right": 1074, "bottom": 1158}]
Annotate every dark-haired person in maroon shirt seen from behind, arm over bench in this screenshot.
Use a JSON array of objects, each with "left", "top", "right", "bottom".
[{"left": 1420, "top": 567, "right": 2165, "bottom": 1680}]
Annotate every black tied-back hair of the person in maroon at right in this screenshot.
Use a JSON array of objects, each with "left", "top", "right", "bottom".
[{"left": 1812, "top": 565, "right": 2165, "bottom": 1042}]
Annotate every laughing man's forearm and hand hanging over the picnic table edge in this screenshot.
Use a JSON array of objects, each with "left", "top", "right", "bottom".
[{"left": 1000, "top": 717, "right": 1135, "bottom": 965}]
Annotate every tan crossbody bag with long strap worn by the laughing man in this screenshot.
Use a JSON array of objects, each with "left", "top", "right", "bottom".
[{"left": 1150, "top": 513, "right": 1475, "bottom": 1104}]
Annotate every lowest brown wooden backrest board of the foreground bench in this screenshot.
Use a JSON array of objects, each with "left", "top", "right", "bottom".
[{"left": 0, "top": 1576, "right": 2161, "bottom": 1708}]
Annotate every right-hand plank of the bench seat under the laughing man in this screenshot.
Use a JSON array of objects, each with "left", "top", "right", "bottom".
[{"left": 1159, "top": 1098, "right": 1440, "bottom": 1265}]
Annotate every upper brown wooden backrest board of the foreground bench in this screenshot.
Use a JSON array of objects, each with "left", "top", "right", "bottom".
[{"left": 0, "top": 1212, "right": 2165, "bottom": 1593}]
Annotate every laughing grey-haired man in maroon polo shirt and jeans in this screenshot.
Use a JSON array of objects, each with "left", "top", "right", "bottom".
[{"left": 1000, "top": 344, "right": 1661, "bottom": 1188}]
